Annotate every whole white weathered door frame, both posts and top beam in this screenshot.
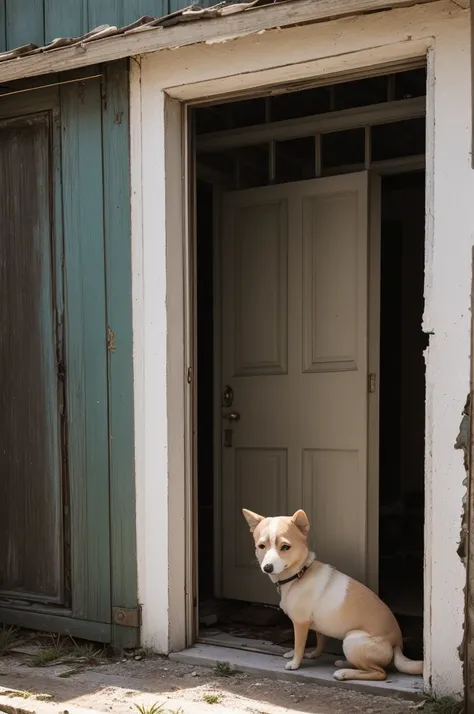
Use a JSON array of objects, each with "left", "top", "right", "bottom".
[{"left": 131, "top": 0, "right": 474, "bottom": 693}]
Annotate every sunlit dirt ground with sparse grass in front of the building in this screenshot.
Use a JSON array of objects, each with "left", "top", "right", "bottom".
[{"left": 0, "top": 654, "right": 419, "bottom": 714}]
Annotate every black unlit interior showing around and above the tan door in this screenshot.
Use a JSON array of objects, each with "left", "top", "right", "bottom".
[{"left": 196, "top": 70, "right": 427, "bottom": 659}]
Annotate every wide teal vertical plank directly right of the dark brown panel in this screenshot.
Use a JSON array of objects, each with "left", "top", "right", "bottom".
[{"left": 61, "top": 73, "right": 110, "bottom": 622}]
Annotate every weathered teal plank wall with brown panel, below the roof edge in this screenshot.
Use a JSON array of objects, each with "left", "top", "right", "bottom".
[{"left": 0, "top": 65, "right": 139, "bottom": 646}]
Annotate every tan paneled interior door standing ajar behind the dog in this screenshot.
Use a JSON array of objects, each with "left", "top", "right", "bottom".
[{"left": 218, "top": 172, "right": 373, "bottom": 603}]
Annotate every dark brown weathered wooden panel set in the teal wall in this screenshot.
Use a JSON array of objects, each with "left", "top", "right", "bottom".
[{"left": 0, "top": 113, "right": 65, "bottom": 604}]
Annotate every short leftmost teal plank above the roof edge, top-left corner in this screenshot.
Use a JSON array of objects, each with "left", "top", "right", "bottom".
[{"left": 5, "top": 0, "right": 44, "bottom": 49}]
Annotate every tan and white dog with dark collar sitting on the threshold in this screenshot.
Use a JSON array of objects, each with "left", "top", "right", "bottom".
[{"left": 242, "top": 508, "right": 423, "bottom": 680}]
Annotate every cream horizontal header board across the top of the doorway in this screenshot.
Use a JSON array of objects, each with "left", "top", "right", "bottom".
[{"left": 160, "top": 0, "right": 469, "bottom": 103}]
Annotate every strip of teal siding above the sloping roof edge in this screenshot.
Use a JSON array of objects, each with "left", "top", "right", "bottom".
[{"left": 0, "top": 0, "right": 219, "bottom": 51}]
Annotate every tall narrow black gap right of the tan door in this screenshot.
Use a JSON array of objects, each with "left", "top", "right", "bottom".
[{"left": 379, "top": 171, "right": 427, "bottom": 656}]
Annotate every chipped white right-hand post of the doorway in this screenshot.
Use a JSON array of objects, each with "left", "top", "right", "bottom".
[{"left": 424, "top": 17, "right": 474, "bottom": 694}]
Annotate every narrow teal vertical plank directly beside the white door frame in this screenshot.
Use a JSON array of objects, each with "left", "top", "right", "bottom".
[{"left": 102, "top": 60, "right": 140, "bottom": 647}]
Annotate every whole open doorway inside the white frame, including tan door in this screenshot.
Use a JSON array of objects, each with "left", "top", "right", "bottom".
[{"left": 193, "top": 68, "right": 426, "bottom": 658}]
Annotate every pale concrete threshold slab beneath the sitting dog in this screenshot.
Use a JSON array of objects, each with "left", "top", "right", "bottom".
[{"left": 169, "top": 643, "right": 423, "bottom": 700}]
